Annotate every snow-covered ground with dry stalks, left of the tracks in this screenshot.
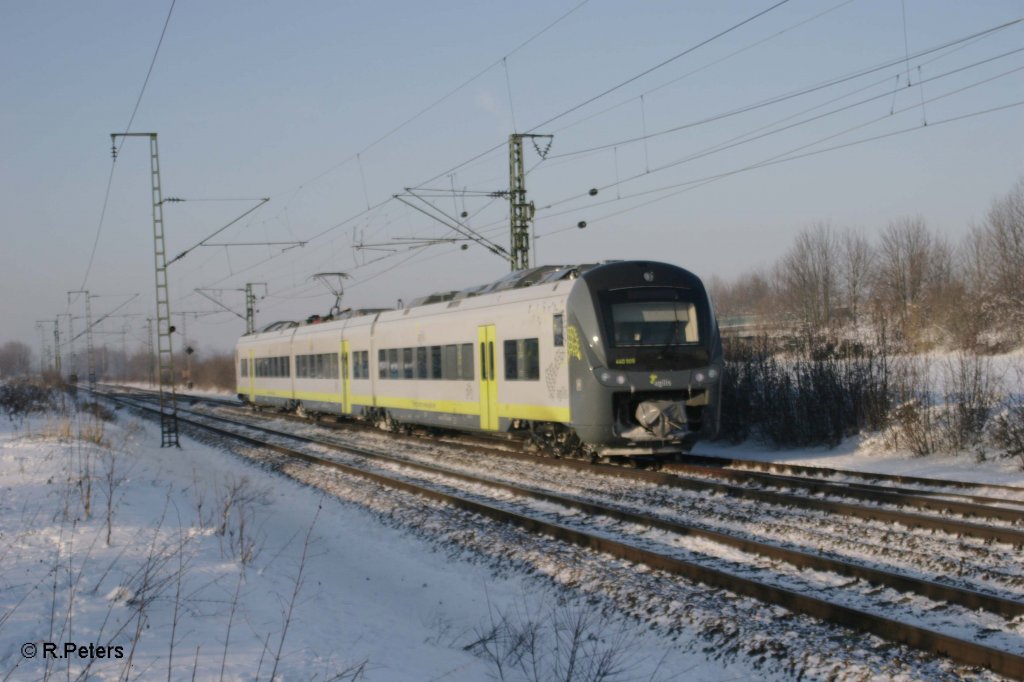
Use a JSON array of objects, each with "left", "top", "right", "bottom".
[{"left": 0, "top": 405, "right": 765, "bottom": 681}]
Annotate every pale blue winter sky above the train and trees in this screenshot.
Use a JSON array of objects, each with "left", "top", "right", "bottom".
[{"left": 0, "top": 0, "right": 1024, "bottom": 360}]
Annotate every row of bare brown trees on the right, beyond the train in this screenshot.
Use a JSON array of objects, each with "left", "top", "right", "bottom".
[{"left": 710, "top": 179, "right": 1024, "bottom": 352}]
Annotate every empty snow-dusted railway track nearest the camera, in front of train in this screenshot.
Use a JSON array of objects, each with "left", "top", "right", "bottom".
[{"left": 105, "top": 385, "right": 1024, "bottom": 679}]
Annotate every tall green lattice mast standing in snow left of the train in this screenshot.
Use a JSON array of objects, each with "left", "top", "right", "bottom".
[{"left": 111, "top": 133, "right": 181, "bottom": 447}]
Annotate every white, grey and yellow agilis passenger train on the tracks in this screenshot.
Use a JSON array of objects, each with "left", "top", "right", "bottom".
[{"left": 236, "top": 260, "right": 723, "bottom": 461}]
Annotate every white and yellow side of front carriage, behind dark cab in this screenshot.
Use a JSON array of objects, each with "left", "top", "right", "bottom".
[{"left": 374, "top": 287, "right": 569, "bottom": 431}]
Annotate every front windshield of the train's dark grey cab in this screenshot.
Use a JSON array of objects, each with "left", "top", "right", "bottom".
[{"left": 607, "top": 288, "right": 699, "bottom": 347}]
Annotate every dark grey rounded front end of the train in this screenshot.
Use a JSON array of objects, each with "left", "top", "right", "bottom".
[{"left": 566, "top": 261, "right": 722, "bottom": 457}]
